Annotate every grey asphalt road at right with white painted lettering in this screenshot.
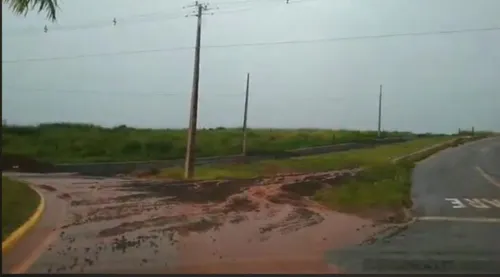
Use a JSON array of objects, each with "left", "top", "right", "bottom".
[{"left": 326, "top": 137, "right": 500, "bottom": 273}]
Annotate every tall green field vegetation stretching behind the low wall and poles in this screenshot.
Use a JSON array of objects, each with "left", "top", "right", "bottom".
[{"left": 2, "top": 123, "right": 408, "bottom": 163}]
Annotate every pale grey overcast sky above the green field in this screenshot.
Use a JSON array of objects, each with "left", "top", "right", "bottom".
[{"left": 2, "top": 0, "right": 500, "bottom": 132}]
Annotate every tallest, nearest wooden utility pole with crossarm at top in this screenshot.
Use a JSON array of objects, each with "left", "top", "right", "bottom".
[{"left": 184, "top": 1, "right": 207, "bottom": 179}]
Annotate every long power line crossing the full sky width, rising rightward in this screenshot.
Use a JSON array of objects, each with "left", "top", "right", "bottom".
[{"left": 2, "top": 27, "right": 500, "bottom": 64}]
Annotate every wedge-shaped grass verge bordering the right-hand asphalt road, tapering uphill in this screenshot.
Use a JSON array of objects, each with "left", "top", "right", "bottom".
[{"left": 314, "top": 134, "right": 482, "bottom": 220}]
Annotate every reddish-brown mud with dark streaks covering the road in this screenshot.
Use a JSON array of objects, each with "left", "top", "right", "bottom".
[{"left": 14, "top": 171, "right": 379, "bottom": 273}]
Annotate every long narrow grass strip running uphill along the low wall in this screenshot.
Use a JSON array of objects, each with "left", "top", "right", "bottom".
[{"left": 159, "top": 136, "right": 452, "bottom": 179}]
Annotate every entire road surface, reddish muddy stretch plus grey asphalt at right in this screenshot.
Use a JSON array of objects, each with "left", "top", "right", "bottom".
[{"left": 2, "top": 138, "right": 500, "bottom": 273}]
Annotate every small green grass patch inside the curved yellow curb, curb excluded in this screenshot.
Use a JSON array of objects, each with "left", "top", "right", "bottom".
[{"left": 2, "top": 176, "right": 40, "bottom": 241}]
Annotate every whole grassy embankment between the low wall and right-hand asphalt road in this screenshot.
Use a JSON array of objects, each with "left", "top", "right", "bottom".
[{"left": 160, "top": 136, "right": 488, "bottom": 215}]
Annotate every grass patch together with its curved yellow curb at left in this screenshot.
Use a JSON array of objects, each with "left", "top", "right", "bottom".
[{"left": 2, "top": 176, "right": 45, "bottom": 254}]
